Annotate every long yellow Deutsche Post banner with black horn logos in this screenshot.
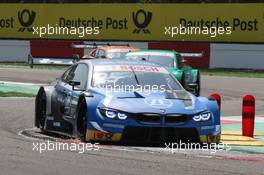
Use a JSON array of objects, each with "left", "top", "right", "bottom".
[{"left": 0, "top": 3, "right": 264, "bottom": 43}]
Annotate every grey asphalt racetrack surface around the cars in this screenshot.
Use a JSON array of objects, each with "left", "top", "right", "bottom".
[{"left": 0, "top": 68, "right": 264, "bottom": 175}]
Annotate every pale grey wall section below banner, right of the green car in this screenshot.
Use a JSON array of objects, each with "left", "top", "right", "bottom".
[{"left": 210, "top": 44, "right": 264, "bottom": 69}]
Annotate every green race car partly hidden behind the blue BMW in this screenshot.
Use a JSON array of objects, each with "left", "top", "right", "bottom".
[{"left": 126, "top": 50, "right": 200, "bottom": 96}]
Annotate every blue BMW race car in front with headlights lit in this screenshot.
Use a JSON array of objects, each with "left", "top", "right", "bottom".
[{"left": 35, "top": 59, "right": 221, "bottom": 143}]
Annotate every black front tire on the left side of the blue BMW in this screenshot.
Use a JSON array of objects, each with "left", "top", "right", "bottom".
[{"left": 77, "top": 98, "right": 87, "bottom": 142}]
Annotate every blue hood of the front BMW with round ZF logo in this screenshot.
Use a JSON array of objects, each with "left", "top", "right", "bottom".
[{"left": 95, "top": 90, "right": 207, "bottom": 115}]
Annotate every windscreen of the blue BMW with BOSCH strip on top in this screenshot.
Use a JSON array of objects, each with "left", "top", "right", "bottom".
[{"left": 92, "top": 65, "right": 182, "bottom": 90}]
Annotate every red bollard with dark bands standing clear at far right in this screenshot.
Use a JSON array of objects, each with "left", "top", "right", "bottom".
[{"left": 242, "top": 95, "right": 255, "bottom": 137}]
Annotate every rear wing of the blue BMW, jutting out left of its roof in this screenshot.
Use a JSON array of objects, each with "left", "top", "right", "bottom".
[{"left": 28, "top": 54, "right": 79, "bottom": 68}]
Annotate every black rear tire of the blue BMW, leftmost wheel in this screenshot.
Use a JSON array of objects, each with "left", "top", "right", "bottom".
[{"left": 36, "top": 91, "right": 47, "bottom": 132}]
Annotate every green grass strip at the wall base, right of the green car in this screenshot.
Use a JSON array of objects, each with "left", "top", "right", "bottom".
[{"left": 201, "top": 69, "right": 264, "bottom": 78}]
